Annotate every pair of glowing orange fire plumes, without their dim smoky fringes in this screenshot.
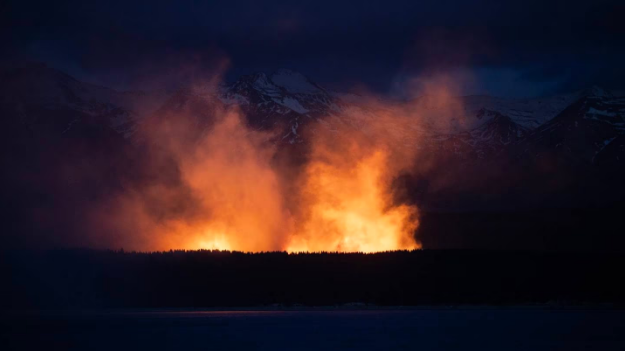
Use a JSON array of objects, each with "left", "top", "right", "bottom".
[{"left": 134, "top": 112, "right": 419, "bottom": 252}]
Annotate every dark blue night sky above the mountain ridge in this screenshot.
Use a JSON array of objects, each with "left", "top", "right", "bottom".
[{"left": 0, "top": 0, "right": 625, "bottom": 96}]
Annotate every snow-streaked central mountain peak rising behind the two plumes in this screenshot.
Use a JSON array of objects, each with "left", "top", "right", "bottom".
[{"left": 148, "top": 69, "right": 345, "bottom": 144}]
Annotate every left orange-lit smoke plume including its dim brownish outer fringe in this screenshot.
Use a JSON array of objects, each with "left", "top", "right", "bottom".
[{"left": 97, "top": 109, "right": 291, "bottom": 251}]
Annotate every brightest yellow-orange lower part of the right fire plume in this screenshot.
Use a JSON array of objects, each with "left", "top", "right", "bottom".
[{"left": 287, "top": 146, "right": 420, "bottom": 252}]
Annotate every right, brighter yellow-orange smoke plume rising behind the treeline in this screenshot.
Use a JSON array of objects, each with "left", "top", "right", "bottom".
[{"left": 287, "top": 126, "right": 419, "bottom": 252}]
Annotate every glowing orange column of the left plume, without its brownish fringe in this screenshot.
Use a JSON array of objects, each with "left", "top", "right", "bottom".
[{"left": 147, "top": 111, "right": 289, "bottom": 251}]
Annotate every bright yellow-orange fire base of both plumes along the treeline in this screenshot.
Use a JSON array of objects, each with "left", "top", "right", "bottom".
[{"left": 158, "top": 144, "right": 420, "bottom": 252}]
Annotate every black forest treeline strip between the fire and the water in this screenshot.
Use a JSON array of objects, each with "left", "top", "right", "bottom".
[{"left": 1, "top": 250, "right": 625, "bottom": 310}]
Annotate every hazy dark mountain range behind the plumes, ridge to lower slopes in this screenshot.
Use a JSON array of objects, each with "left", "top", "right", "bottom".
[{"left": 0, "top": 64, "right": 625, "bottom": 250}]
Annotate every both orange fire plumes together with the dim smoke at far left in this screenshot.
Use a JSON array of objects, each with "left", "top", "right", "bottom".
[{"left": 97, "top": 104, "right": 420, "bottom": 252}]
